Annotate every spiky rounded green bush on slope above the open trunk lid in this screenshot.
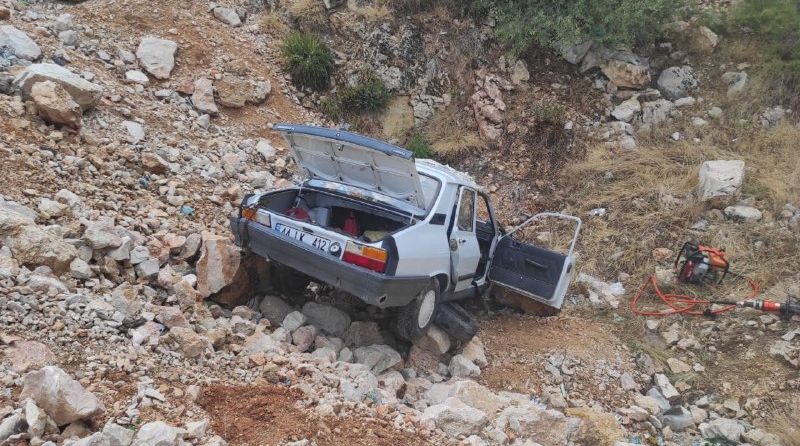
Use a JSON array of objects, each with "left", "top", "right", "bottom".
[{"left": 283, "top": 31, "right": 334, "bottom": 90}]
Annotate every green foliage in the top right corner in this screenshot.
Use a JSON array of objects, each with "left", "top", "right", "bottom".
[{"left": 730, "top": 0, "right": 800, "bottom": 91}]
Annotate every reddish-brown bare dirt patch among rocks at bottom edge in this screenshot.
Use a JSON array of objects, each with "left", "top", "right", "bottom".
[{"left": 199, "top": 385, "right": 432, "bottom": 446}]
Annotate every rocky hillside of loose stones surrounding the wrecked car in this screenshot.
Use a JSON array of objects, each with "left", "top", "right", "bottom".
[{"left": 0, "top": 0, "right": 800, "bottom": 446}]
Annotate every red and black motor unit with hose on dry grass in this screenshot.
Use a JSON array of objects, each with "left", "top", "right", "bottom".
[{"left": 675, "top": 242, "right": 730, "bottom": 284}]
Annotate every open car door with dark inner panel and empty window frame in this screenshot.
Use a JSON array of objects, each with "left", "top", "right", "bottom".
[{"left": 489, "top": 212, "right": 581, "bottom": 309}]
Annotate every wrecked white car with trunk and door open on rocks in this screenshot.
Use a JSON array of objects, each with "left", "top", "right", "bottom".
[{"left": 231, "top": 124, "right": 581, "bottom": 340}]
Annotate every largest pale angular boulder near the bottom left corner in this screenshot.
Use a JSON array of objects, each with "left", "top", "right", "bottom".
[{"left": 20, "top": 366, "right": 105, "bottom": 426}]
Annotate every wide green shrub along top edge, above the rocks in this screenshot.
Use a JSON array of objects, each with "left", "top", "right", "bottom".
[{"left": 471, "top": 0, "right": 683, "bottom": 55}]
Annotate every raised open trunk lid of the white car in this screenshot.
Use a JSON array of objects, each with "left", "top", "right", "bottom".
[{"left": 272, "top": 124, "right": 425, "bottom": 209}]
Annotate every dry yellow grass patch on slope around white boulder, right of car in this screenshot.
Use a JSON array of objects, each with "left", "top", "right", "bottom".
[{"left": 566, "top": 116, "right": 800, "bottom": 293}]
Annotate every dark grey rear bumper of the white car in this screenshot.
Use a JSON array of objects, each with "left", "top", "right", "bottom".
[{"left": 230, "top": 216, "right": 431, "bottom": 308}]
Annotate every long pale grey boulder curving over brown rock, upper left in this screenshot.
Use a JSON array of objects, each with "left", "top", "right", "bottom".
[{"left": 14, "top": 63, "right": 103, "bottom": 111}]
